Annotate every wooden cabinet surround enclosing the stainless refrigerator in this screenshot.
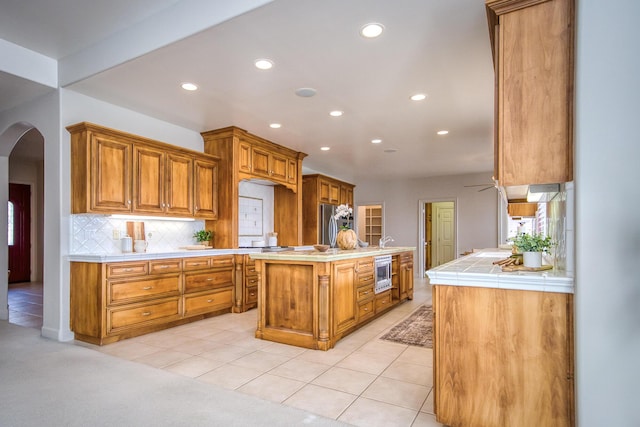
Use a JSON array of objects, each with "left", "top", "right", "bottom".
[{"left": 302, "top": 174, "right": 355, "bottom": 245}]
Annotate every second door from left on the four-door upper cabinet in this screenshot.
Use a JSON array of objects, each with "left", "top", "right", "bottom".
[{"left": 133, "top": 145, "right": 165, "bottom": 213}]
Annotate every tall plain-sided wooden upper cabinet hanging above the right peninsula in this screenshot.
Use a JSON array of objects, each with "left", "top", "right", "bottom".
[{"left": 486, "top": 0, "right": 574, "bottom": 186}]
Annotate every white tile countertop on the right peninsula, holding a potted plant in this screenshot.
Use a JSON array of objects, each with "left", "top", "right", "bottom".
[{"left": 427, "top": 249, "right": 573, "bottom": 294}]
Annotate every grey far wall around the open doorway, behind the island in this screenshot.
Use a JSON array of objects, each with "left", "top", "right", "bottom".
[{"left": 354, "top": 172, "right": 498, "bottom": 260}]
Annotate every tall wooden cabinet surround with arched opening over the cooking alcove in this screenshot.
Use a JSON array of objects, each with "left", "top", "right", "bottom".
[{"left": 202, "top": 126, "right": 306, "bottom": 248}]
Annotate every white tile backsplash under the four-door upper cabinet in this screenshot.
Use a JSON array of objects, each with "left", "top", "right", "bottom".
[{"left": 70, "top": 214, "right": 204, "bottom": 254}]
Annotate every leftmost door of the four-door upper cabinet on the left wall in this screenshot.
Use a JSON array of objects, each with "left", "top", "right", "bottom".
[{"left": 90, "top": 134, "right": 132, "bottom": 213}]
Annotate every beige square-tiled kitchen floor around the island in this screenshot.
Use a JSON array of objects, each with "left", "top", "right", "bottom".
[{"left": 85, "top": 280, "right": 440, "bottom": 427}]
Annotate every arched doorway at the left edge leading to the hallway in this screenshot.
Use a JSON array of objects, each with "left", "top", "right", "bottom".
[{"left": 0, "top": 122, "right": 44, "bottom": 328}]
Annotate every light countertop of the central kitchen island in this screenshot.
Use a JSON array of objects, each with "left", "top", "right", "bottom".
[{"left": 251, "top": 246, "right": 416, "bottom": 262}]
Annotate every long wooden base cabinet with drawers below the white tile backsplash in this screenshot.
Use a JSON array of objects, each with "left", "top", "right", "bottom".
[{"left": 70, "top": 255, "right": 234, "bottom": 345}]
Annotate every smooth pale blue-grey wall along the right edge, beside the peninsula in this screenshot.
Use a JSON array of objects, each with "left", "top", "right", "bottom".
[{"left": 575, "top": 0, "right": 640, "bottom": 427}]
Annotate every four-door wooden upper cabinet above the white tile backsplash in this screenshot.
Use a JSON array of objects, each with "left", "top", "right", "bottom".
[{"left": 67, "top": 123, "right": 218, "bottom": 219}]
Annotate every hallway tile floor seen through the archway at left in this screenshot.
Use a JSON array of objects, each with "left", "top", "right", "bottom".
[{"left": 7, "top": 282, "right": 42, "bottom": 329}]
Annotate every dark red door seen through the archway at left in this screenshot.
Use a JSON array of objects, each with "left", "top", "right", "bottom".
[{"left": 8, "top": 183, "right": 31, "bottom": 283}]
